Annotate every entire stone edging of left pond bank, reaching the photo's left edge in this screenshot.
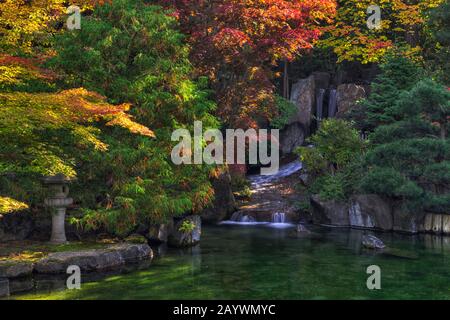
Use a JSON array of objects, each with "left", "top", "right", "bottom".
[{"left": 0, "top": 243, "right": 153, "bottom": 297}]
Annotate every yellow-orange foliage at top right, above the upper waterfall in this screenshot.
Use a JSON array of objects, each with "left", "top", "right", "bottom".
[{"left": 317, "top": 0, "right": 444, "bottom": 64}]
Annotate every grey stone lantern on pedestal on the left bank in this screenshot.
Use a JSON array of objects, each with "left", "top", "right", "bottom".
[{"left": 42, "top": 174, "right": 73, "bottom": 244}]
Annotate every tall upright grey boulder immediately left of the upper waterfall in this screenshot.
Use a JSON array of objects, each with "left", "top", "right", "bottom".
[{"left": 290, "top": 75, "right": 316, "bottom": 134}]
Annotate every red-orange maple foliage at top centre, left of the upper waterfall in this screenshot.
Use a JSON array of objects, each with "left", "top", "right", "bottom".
[{"left": 162, "top": 0, "right": 336, "bottom": 128}]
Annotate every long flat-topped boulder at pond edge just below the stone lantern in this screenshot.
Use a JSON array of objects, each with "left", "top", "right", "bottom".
[{"left": 34, "top": 243, "right": 153, "bottom": 274}]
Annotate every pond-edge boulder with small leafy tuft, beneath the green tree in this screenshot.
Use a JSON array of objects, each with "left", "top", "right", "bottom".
[{"left": 168, "top": 215, "right": 202, "bottom": 248}]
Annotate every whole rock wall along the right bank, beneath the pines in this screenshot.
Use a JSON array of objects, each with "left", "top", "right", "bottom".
[{"left": 310, "top": 195, "right": 450, "bottom": 234}]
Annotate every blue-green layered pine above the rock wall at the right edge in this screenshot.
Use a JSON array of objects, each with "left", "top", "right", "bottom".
[{"left": 362, "top": 79, "right": 450, "bottom": 213}]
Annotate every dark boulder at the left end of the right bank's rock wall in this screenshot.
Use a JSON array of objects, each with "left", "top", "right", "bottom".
[{"left": 311, "top": 195, "right": 350, "bottom": 227}]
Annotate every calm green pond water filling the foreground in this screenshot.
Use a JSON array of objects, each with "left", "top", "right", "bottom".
[{"left": 11, "top": 225, "right": 450, "bottom": 299}]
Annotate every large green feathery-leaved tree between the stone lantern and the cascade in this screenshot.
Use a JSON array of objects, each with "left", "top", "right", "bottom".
[{"left": 53, "top": 0, "right": 217, "bottom": 233}]
